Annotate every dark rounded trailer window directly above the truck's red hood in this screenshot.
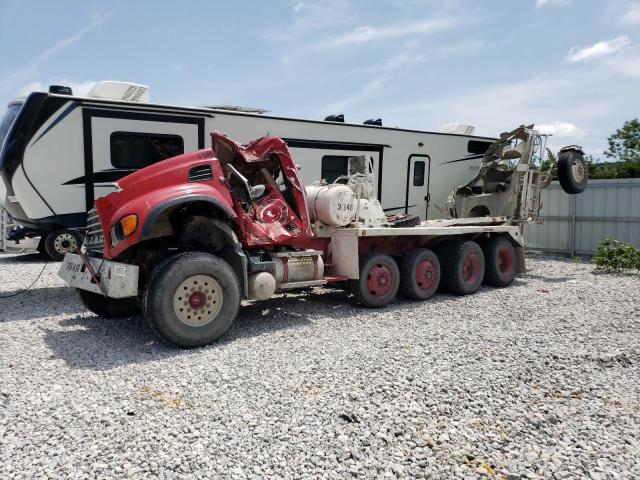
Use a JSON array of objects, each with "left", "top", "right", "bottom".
[{"left": 110, "top": 132, "right": 184, "bottom": 168}]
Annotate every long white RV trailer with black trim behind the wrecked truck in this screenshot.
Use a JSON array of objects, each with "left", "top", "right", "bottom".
[{"left": 0, "top": 82, "right": 494, "bottom": 253}]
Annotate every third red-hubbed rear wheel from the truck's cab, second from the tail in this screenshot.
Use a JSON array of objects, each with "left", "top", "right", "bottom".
[{"left": 444, "top": 241, "right": 484, "bottom": 295}]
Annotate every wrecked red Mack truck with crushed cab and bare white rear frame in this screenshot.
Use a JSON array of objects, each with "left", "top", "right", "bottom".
[{"left": 60, "top": 125, "right": 584, "bottom": 347}]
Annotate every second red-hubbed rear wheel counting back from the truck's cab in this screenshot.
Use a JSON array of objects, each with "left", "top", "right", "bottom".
[{"left": 400, "top": 248, "right": 440, "bottom": 300}]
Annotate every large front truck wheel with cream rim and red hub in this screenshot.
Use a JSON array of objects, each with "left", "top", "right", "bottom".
[{"left": 142, "top": 252, "right": 240, "bottom": 348}]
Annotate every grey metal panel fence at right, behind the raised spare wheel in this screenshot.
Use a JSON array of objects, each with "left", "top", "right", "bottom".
[{"left": 525, "top": 178, "right": 640, "bottom": 256}]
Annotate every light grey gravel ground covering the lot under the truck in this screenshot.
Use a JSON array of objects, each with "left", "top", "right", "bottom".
[{"left": 0, "top": 255, "right": 640, "bottom": 479}]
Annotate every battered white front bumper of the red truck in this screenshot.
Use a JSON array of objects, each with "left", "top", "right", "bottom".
[{"left": 58, "top": 253, "right": 138, "bottom": 298}]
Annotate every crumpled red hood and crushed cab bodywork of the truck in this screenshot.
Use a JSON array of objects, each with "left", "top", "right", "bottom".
[{"left": 96, "top": 132, "right": 316, "bottom": 259}]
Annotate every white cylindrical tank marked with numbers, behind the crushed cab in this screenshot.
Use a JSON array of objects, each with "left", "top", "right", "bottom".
[{"left": 307, "top": 184, "right": 356, "bottom": 227}]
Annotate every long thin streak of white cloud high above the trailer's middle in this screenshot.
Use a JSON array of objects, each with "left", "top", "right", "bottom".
[{"left": 312, "top": 17, "right": 459, "bottom": 50}]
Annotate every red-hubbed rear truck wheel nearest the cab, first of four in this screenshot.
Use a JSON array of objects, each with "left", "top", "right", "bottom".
[{"left": 350, "top": 253, "right": 400, "bottom": 308}]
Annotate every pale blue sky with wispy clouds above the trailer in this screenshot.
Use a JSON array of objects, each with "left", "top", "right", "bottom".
[{"left": 0, "top": 0, "right": 640, "bottom": 157}]
